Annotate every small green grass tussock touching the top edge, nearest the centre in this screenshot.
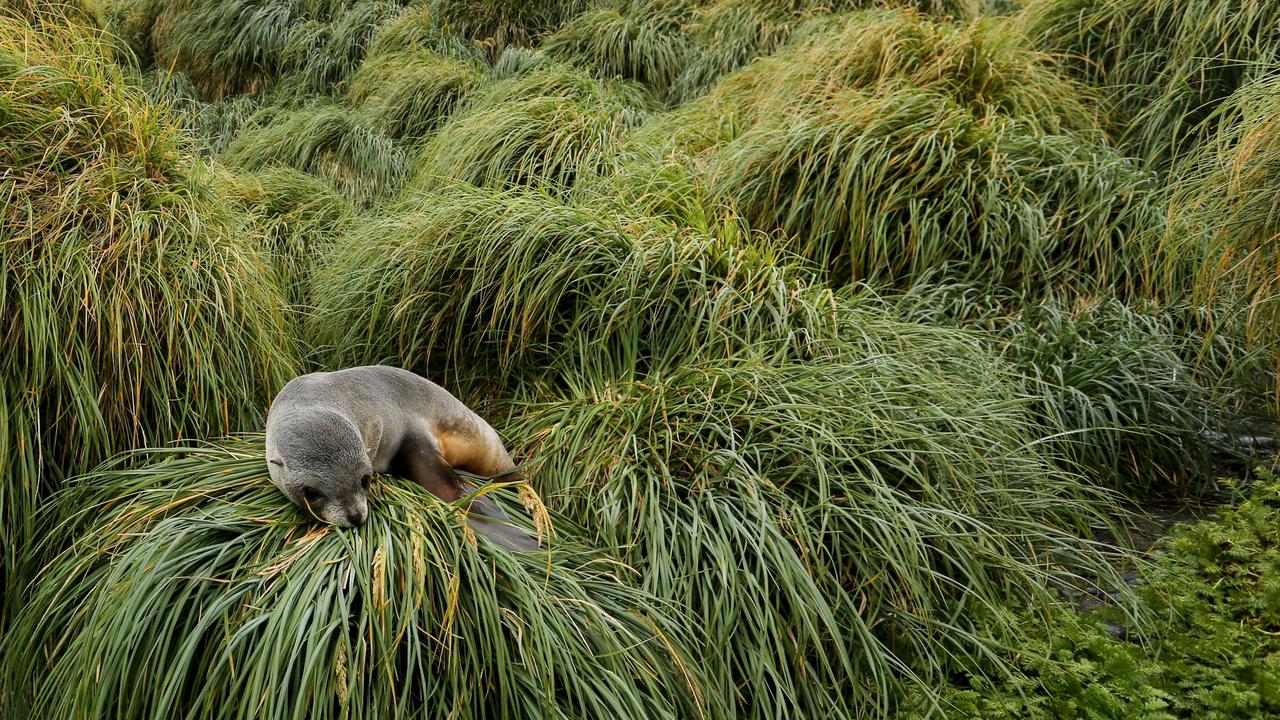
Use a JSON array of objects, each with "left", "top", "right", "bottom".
[{"left": 541, "top": 3, "right": 690, "bottom": 92}]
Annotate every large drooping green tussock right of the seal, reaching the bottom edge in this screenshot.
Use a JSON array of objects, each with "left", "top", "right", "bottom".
[{"left": 504, "top": 338, "right": 1131, "bottom": 717}]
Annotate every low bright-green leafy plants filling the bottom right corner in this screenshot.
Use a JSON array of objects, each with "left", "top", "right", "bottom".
[{"left": 900, "top": 473, "right": 1280, "bottom": 720}]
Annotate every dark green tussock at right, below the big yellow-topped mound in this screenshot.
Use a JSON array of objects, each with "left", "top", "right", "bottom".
[{"left": 893, "top": 283, "right": 1223, "bottom": 496}]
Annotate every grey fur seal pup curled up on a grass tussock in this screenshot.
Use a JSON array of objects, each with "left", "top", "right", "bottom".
[{"left": 266, "top": 365, "right": 538, "bottom": 550}]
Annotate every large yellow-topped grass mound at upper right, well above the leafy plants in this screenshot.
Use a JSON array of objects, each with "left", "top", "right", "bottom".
[{"left": 650, "top": 10, "right": 1158, "bottom": 290}]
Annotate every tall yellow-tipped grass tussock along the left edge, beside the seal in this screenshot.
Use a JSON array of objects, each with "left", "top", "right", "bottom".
[{"left": 0, "top": 15, "right": 296, "bottom": 607}]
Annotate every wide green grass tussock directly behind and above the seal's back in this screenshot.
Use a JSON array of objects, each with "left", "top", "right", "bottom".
[{"left": 312, "top": 183, "right": 839, "bottom": 384}]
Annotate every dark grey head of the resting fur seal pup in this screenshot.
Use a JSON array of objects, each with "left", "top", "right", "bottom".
[{"left": 266, "top": 410, "right": 374, "bottom": 528}]
